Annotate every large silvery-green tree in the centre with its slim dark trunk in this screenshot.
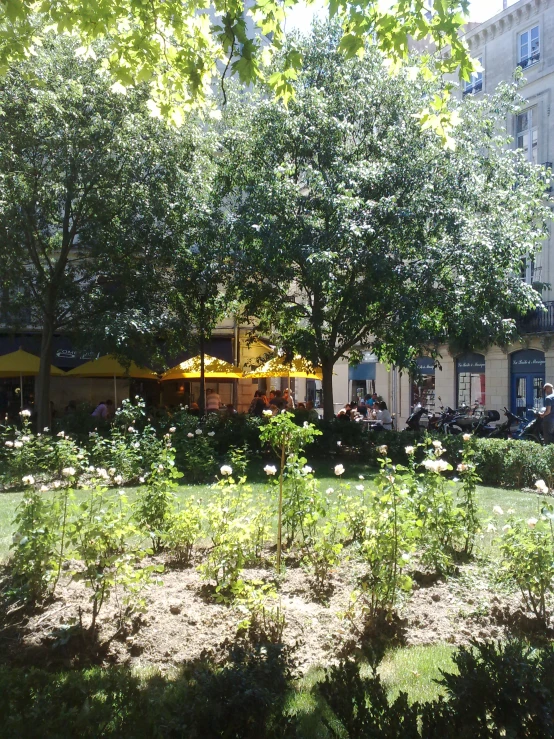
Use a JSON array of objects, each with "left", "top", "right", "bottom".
[{"left": 223, "top": 26, "right": 549, "bottom": 417}]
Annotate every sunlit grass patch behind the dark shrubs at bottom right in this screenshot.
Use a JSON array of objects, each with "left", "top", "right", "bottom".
[{"left": 379, "top": 644, "right": 456, "bottom": 703}]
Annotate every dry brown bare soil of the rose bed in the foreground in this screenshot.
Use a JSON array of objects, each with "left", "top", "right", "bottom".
[{"left": 0, "top": 557, "right": 551, "bottom": 672}]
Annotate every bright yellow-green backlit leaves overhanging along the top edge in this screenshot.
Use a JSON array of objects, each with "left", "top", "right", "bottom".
[{"left": 0, "top": 0, "right": 475, "bottom": 139}]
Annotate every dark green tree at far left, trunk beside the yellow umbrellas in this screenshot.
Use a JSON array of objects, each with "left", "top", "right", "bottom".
[{"left": 0, "top": 39, "right": 203, "bottom": 428}]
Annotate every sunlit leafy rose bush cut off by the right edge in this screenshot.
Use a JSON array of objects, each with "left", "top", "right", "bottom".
[{"left": 498, "top": 506, "right": 554, "bottom": 621}]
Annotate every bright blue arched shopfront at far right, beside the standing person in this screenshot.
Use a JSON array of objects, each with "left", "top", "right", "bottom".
[{"left": 510, "top": 349, "right": 545, "bottom": 418}]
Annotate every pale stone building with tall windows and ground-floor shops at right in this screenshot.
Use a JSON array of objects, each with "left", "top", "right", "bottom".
[{"left": 356, "top": 0, "right": 554, "bottom": 428}]
